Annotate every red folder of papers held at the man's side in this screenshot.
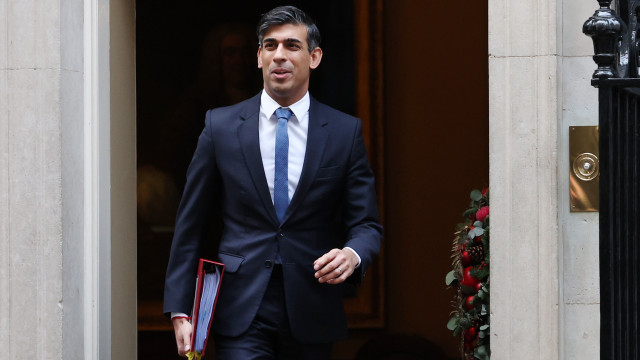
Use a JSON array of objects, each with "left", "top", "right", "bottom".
[{"left": 191, "top": 259, "right": 224, "bottom": 358}]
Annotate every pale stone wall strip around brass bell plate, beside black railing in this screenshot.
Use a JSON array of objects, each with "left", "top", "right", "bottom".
[{"left": 558, "top": 0, "right": 600, "bottom": 360}]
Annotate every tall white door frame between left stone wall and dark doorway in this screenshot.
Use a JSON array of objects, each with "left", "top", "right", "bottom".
[{"left": 83, "top": 0, "right": 137, "bottom": 359}]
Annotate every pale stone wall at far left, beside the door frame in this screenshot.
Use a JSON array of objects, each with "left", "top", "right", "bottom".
[{"left": 0, "top": 0, "right": 84, "bottom": 359}]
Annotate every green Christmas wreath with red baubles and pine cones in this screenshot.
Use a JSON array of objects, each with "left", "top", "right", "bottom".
[{"left": 446, "top": 189, "right": 491, "bottom": 360}]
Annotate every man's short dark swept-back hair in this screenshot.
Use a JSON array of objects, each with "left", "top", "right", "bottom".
[{"left": 256, "top": 6, "right": 320, "bottom": 52}]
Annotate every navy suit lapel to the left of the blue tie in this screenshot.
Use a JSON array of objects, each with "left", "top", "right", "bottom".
[{"left": 238, "top": 94, "right": 278, "bottom": 224}]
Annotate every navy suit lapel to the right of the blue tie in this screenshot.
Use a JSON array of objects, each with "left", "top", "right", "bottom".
[{"left": 282, "top": 98, "right": 328, "bottom": 223}]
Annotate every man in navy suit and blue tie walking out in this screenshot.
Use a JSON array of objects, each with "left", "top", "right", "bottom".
[{"left": 164, "top": 6, "right": 382, "bottom": 360}]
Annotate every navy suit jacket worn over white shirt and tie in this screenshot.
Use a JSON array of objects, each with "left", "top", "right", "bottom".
[{"left": 164, "top": 94, "right": 382, "bottom": 343}]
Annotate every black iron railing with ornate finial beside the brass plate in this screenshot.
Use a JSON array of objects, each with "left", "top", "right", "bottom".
[{"left": 583, "top": 0, "right": 640, "bottom": 360}]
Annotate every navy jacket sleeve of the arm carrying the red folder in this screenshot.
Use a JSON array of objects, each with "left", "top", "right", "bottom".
[{"left": 163, "top": 110, "right": 219, "bottom": 314}]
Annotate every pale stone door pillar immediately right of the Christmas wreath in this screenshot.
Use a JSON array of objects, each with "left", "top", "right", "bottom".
[{"left": 489, "top": 0, "right": 559, "bottom": 360}]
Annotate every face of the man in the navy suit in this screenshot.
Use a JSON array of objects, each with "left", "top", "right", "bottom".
[{"left": 258, "top": 24, "right": 322, "bottom": 106}]
